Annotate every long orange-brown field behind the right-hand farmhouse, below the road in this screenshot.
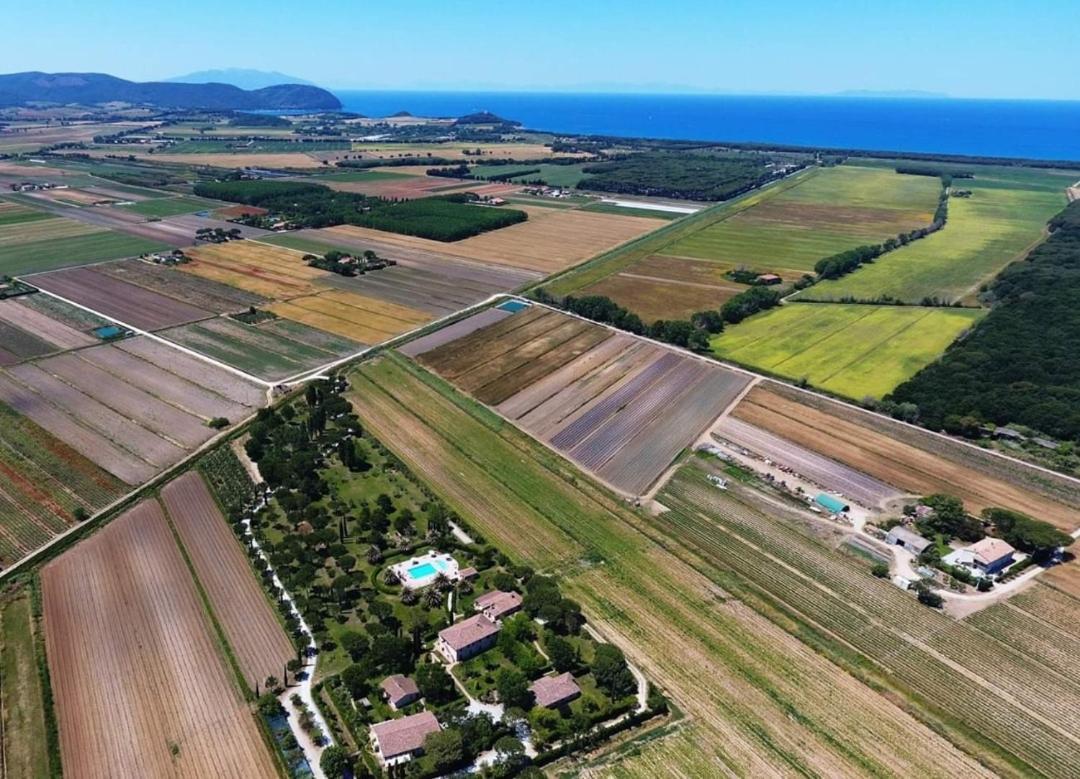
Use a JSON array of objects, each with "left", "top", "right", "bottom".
[{"left": 733, "top": 384, "right": 1078, "bottom": 532}]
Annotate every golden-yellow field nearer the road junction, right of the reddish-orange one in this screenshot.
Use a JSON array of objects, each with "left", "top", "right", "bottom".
[{"left": 269, "top": 291, "right": 432, "bottom": 345}]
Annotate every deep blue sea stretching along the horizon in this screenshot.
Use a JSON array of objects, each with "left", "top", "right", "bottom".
[{"left": 335, "top": 91, "right": 1080, "bottom": 161}]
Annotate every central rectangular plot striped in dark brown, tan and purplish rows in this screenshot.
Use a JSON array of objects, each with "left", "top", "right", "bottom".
[{"left": 417, "top": 306, "right": 748, "bottom": 495}]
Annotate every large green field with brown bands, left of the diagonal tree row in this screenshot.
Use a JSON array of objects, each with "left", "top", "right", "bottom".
[{"left": 660, "top": 165, "right": 941, "bottom": 271}]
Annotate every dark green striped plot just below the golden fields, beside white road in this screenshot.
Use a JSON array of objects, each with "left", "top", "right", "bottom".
[{"left": 162, "top": 318, "right": 361, "bottom": 381}]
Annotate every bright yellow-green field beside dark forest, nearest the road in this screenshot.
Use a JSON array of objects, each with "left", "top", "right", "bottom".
[{"left": 712, "top": 304, "right": 985, "bottom": 400}]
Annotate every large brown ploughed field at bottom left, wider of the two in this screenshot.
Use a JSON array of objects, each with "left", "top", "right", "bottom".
[{"left": 41, "top": 500, "right": 278, "bottom": 779}]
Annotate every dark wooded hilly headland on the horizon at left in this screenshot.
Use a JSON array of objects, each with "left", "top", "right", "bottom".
[{"left": 0, "top": 72, "right": 341, "bottom": 110}]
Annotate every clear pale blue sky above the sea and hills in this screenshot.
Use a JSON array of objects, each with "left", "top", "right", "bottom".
[{"left": 8, "top": 0, "right": 1080, "bottom": 99}]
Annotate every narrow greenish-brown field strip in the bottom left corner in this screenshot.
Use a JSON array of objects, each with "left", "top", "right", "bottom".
[{"left": 0, "top": 589, "right": 51, "bottom": 779}]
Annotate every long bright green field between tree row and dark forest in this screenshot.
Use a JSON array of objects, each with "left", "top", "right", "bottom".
[{"left": 801, "top": 170, "right": 1071, "bottom": 303}]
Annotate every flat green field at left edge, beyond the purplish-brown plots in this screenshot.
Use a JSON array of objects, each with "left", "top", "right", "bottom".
[{"left": 0, "top": 230, "right": 170, "bottom": 276}]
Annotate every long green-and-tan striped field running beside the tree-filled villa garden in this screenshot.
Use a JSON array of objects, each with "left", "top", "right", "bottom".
[{"left": 351, "top": 358, "right": 985, "bottom": 776}]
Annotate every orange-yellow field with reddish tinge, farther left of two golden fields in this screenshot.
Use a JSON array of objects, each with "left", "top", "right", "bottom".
[{"left": 179, "top": 241, "right": 326, "bottom": 299}]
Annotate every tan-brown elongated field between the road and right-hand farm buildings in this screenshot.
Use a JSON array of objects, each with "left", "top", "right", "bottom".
[{"left": 733, "top": 382, "right": 1080, "bottom": 532}]
